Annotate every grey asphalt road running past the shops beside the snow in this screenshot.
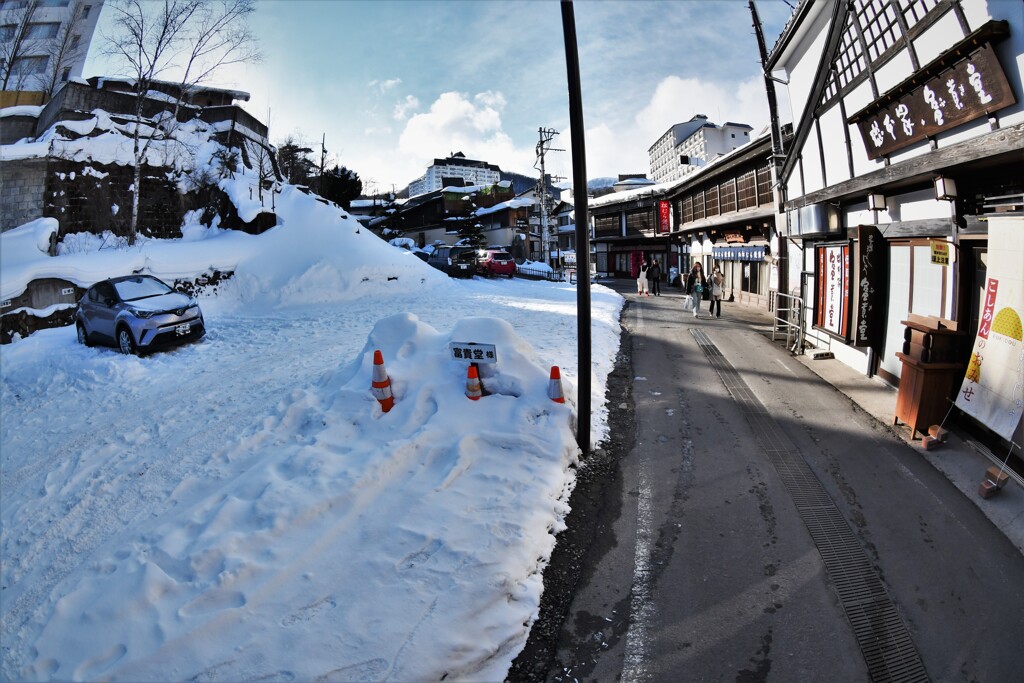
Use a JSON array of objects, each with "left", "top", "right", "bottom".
[{"left": 520, "top": 283, "right": 1024, "bottom": 682}]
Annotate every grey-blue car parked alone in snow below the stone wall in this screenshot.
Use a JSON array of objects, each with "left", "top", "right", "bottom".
[{"left": 75, "top": 275, "right": 206, "bottom": 355}]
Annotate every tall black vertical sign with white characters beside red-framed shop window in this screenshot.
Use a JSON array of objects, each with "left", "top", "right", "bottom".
[{"left": 856, "top": 225, "right": 889, "bottom": 355}]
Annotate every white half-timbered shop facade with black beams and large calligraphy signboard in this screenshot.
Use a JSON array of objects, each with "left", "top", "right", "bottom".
[{"left": 766, "top": 0, "right": 1024, "bottom": 383}]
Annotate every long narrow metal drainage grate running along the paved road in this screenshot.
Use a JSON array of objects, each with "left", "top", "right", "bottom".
[{"left": 691, "top": 330, "right": 929, "bottom": 683}]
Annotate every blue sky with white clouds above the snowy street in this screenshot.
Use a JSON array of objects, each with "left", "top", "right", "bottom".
[{"left": 84, "top": 0, "right": 795, "bottom": 191}]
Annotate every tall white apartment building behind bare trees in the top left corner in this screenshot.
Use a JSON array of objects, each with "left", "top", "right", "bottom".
[{"left": 0, "top": 0, "right": 103, "bottom": 95}]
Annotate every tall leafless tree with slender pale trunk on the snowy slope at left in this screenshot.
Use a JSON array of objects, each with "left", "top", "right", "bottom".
[{"left": 105, "top": 0, "right": 260, "bottom": 244}]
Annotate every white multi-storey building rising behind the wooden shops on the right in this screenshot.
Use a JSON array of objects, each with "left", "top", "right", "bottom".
[{"left": 647, "top": 114, "right": 754, "bottom": 183}]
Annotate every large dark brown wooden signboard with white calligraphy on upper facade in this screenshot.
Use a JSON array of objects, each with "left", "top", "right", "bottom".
[{"left": 851, "top": 44, "right": 1016, "bottom": 159}]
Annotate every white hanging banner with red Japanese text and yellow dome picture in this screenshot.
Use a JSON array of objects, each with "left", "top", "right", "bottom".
[{"left": 956, "top": 216, "right": 1024, "bottom": 443}]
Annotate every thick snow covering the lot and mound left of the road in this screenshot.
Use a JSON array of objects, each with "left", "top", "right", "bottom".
[{"left": 0, "top": 114, "right": 623, "bottom": 681}]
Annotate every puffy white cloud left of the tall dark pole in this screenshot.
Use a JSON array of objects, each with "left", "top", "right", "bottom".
[{"left": 398, "top": 91, "right": 534, "bottom": 178}]
